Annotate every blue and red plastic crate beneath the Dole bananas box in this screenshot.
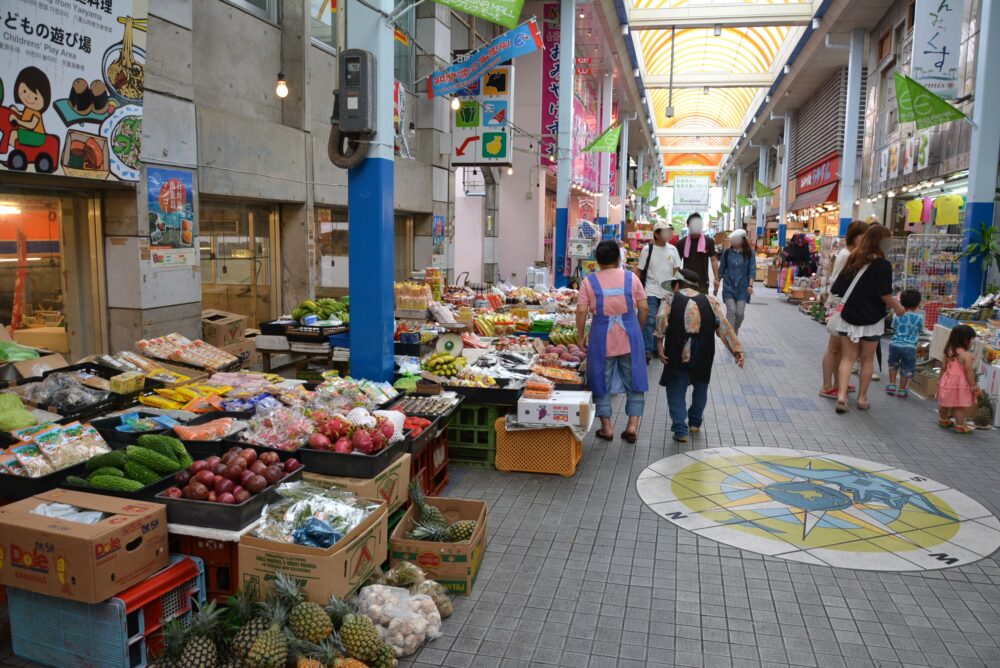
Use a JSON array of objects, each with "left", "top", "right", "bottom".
[{"left": 8, "top": 555, "right": 205, "bottom": 668}]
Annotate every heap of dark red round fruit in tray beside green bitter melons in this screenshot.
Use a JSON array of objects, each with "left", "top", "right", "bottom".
[{"left": 160, "top": 446, "right": 302, "bottom": 504}]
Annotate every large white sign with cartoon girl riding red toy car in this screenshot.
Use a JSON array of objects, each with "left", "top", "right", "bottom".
[{"left": 0, "top": 0, "right": 147, "bottom": 181}]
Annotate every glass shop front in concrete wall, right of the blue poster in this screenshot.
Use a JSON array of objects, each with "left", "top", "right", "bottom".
[{"left": 199, "top": 203, "right": 281, "bottom": 325}]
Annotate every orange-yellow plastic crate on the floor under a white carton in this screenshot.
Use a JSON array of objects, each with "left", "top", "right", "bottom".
[{"left": 494, "top": 419, "right": 583, "bottom": 477}]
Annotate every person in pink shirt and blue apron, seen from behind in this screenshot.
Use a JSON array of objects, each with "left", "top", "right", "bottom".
[{"left": 576, "top": 240, "right": 649, "bottom": 443}]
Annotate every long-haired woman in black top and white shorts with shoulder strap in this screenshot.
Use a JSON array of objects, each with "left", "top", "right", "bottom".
[{"left": 830, "top": 225, "right": 905, "bottom": 413}]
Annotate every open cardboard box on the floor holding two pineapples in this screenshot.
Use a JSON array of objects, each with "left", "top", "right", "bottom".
[{"left": 389, "top": 497, "right": 486, "bottom": 594}]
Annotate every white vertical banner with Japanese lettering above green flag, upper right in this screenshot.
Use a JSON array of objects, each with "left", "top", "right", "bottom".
[{"left": 910, "top": 0, "right": 965, "bottom": 100}]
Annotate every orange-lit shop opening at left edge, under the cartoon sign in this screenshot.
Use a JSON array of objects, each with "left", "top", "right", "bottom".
[{"left": 0, "top": 190, "right": 107, "bottom": 359}]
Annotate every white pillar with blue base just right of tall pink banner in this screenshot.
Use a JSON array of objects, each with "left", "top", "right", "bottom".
[{"left": 552, "top": 0, "right": 576, "bottom": 288}]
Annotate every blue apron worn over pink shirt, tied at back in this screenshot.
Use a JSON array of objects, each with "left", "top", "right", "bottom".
[{"left": 587, "top": 271, "right": 649, "bottom": 397}]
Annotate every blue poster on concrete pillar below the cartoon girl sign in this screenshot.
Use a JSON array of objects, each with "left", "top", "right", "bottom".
[{"left": 146, "top": 167, "right": 199, "bottom": 267}]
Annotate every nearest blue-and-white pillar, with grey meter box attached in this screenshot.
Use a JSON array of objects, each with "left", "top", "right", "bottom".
[{"left": 347, "top": 0, "right": 395, "bottom": 380}]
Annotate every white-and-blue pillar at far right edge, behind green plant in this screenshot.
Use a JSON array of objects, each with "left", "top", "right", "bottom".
[{"left": 958, "top": 2, "right": 1000, "bottom": 306}]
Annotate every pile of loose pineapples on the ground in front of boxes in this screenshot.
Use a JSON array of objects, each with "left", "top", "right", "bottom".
[{"left": 155, "top": 573, "right": 398, "bottom": 668}]
